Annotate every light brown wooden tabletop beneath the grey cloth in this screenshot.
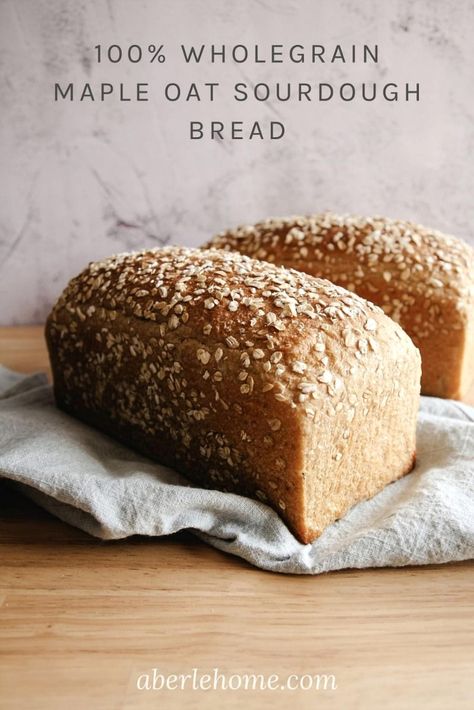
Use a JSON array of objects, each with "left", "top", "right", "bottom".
[{"left": 0, "top": 327, "right": 474, "bottom": 710}]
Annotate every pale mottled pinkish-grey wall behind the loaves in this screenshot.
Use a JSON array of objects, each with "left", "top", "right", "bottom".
[{"left": 0, "top": 0, "right": 474, "bottom": 323}]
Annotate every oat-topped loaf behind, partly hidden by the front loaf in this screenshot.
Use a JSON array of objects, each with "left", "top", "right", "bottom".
[{"left": 205, "top": 213, "right": 474, "bottom": 399}]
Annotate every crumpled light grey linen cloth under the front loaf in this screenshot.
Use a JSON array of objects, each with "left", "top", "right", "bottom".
[{"left": 0, "top": 367, "right": 474, "bottom": 574}]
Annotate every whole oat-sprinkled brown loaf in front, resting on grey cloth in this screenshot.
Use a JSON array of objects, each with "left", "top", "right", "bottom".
[{"left": 46, "top": 247, "right": 420, "bottom": 542}]
